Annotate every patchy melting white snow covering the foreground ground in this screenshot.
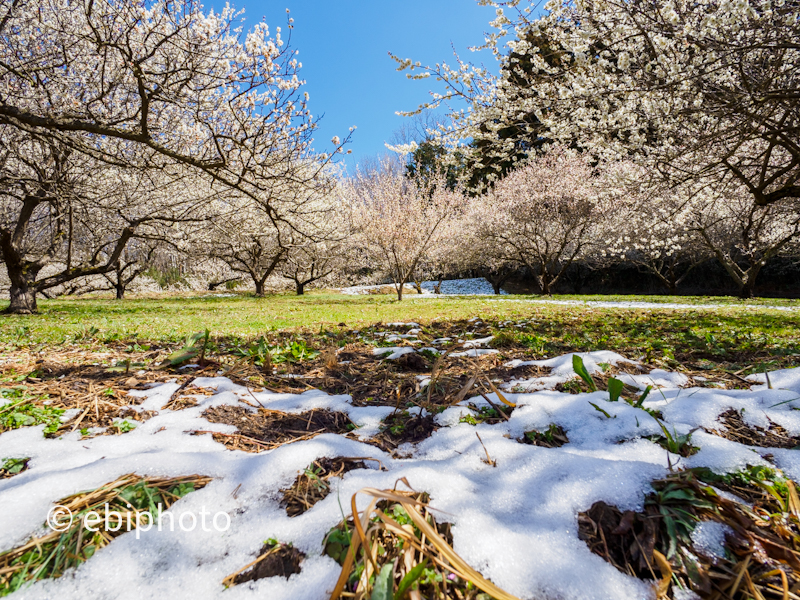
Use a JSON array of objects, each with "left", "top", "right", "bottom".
[{"left": 0, "top": 354, "right": 800, "bottom": 600}]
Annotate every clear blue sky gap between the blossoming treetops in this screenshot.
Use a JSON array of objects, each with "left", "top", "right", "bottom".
[{"left": 206, "top": 0, "right": 504, "bottom": 165}]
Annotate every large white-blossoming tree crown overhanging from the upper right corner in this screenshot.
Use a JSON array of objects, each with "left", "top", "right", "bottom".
[{"left": 400, "top": 0, "right": 800, "bottom": 205}]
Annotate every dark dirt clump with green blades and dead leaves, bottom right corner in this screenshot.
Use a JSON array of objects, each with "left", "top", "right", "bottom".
[{"left": 578, "top": 467, "right": 800, "bottom": 600}]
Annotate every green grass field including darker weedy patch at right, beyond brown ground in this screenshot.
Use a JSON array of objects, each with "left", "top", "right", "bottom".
[{"left": 0, "top": 293, "right": 800, "bottom": 370}]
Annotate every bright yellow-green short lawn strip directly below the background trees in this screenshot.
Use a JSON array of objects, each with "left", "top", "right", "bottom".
[{"left": 0, "top": 293, "right": 800, "bottom": 343}]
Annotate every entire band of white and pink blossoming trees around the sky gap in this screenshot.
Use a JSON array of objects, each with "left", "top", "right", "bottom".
[{"left": 0, "top": 0, "right": 800, "bottom": 312}]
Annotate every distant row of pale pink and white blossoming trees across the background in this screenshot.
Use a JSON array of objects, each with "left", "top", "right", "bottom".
[{"left": 3, "top": 147, "right": 800, "bottom": 300}]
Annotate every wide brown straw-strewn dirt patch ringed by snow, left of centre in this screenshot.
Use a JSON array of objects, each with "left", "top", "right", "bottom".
[{"left": 197, "top": 406, "right": 355, "bottom": 452}]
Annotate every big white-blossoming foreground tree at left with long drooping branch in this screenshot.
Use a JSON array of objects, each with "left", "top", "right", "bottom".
[{"left": 0, "top": 0, "right": 347, "bottom": 312}]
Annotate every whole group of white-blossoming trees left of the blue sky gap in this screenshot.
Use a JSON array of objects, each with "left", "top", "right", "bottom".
[{"left": 0, "top": 0, "right": 347, "bottom": 313}]
